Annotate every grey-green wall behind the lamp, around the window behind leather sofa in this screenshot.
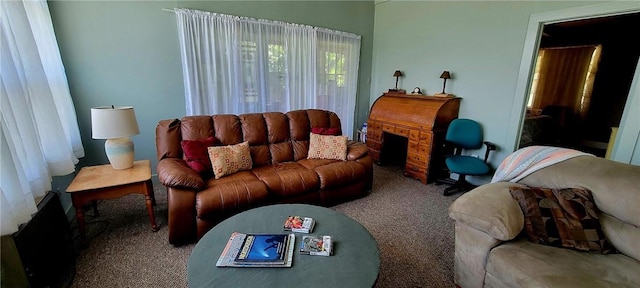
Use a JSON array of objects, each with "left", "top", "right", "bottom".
[{"left": 48, "top": 1, "right": 374, "bottom": 173}]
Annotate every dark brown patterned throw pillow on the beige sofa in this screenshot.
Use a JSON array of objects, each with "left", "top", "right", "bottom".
[{"left": 509, "top": 186, "right": 614, "bottom": 254}]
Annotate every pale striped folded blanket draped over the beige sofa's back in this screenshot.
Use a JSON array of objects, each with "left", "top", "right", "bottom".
[{"left": 491, "top": 146, "right": 594, "bottom": 183}]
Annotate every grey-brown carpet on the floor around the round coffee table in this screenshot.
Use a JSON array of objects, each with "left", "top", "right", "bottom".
[{"left": 63, "top": 166, "right": 460, "bottom": 287}]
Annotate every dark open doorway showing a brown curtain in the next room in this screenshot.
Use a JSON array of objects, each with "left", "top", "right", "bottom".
[{"left": 518, "top": 13, "right": 640, "bottom": 157}]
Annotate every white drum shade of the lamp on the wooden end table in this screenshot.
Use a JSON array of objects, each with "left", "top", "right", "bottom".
[{"left": 91, "top": 106, "right": 140, "bottom": 139}]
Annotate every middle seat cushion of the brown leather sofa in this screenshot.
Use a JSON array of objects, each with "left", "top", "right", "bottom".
[{"left": 251, "top": 162, "right": 320, "bottom": 197}]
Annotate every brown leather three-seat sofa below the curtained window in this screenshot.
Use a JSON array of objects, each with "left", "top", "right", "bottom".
[{"left": 156, "top": 109, "right": 373, "bottom": 245}]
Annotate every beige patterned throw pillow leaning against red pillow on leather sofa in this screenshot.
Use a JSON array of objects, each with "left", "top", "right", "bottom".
[{"left": 207, "top": 142, "right": 253, "bottom": 179}]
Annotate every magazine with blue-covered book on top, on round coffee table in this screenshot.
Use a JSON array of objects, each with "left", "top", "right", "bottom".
[{"left": 216, "top": 232, "right": 295, "bottom": 267}]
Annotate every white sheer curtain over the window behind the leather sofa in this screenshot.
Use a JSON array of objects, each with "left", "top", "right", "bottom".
[{"left": 175, "top": 9, "right": 360, "bottom": 137}]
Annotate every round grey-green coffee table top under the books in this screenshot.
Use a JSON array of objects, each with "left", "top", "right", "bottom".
[{"left": 187, "top": 204, "right": 380, "bottom": 288}]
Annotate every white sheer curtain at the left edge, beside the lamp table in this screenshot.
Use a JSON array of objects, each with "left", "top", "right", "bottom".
[{"left": 0, "top": 0, "right": 84, "bottom": 235}]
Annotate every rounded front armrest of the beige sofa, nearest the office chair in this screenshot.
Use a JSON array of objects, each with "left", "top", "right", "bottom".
[{"left": 449, "top": 182, "right": 524, "bottom": 241}]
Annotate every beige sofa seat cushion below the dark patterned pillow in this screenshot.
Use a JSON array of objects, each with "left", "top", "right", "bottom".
[{"left": 485, "top": 239, "right": 640, "bottom": 287}]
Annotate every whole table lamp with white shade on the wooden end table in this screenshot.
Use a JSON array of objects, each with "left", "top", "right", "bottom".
[{"left": 91, "top": 105, "right": 140, "bottom": 169}]
